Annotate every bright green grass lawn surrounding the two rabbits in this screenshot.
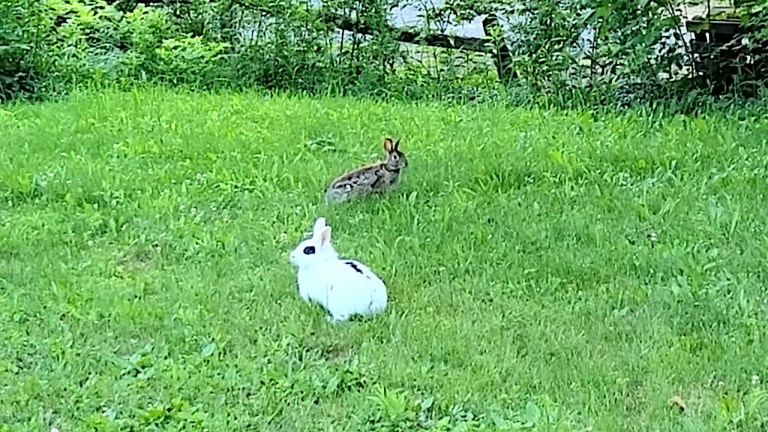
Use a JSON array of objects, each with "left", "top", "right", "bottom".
[{"left": 0, "top": 86, "right": 768, "bottom": 432}]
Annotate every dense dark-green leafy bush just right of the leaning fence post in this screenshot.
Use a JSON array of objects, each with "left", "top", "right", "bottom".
[{"left": 438, "top": 0, "right": 690, "bottom": 106}]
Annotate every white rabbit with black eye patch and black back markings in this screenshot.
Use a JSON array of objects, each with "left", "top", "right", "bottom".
[{"left": 290, "top": 217, "right": 387, "bottom": 322}]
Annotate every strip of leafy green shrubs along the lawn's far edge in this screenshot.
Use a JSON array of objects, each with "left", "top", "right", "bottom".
[{"left": 0, "top": 0, "right": 768, "bottom": 107}]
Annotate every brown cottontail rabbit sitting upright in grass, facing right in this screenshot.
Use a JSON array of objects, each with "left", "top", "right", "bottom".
[{"left": 325, "top": 138, "right": 408, "bottom": 203}]
